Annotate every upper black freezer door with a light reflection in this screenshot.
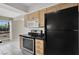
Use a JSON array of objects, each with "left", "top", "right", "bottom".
[{"left": 45, "top": 7, "right": 78, "bottom": 31}]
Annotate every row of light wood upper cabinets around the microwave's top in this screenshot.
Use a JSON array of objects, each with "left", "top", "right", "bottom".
[{"left": 24, "top": 9, "right": 46, "bottom": 27}]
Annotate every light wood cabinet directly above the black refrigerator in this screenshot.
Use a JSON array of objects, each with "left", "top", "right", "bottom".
[{"left": 46, "top": 3, "right": 77, "bottom": 13}]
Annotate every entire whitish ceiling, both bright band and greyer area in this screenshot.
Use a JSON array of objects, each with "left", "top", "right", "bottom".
[{"left": 0, "top": 3, "right": 56, "bottom": 18}]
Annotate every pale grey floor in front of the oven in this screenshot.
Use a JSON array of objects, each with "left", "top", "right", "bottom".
[{"left": 0, "top": 40, "right": 30, "bottom": 55}]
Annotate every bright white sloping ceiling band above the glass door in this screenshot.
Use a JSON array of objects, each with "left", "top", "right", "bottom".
[{"left": 0, "top": 3, "right": 25, "bottom": 18}]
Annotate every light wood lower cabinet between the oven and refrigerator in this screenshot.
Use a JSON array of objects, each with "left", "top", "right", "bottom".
[{"left": 35, "top": 39, "right": 44, "bottom": 55}]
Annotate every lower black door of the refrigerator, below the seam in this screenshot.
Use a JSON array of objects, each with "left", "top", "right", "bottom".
[{"left": 47, "top": 31, "right": 78, "bottom": 55}]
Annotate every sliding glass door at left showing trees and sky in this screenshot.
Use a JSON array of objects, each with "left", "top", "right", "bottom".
[{"left": 0, "top": 20, "right": 10, "bottom": 42}]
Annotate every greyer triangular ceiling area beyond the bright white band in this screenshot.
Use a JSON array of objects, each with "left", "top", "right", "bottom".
[{"left": 6, "top": 3, "right": 57, "bottom": 12}]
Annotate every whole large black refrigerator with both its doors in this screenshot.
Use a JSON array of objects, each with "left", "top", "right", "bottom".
[{"left": 44, "top": 6, "right": 78, "bottom": 55}]
